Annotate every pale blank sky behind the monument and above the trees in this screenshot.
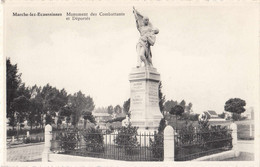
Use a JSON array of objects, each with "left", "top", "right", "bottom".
[{"left": 5, "top": 5, "right": 259, "bottom": 113}]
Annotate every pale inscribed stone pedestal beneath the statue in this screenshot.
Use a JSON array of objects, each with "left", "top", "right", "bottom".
[{"left": 129, "top": 67, "right": 163, "bottom": 132}]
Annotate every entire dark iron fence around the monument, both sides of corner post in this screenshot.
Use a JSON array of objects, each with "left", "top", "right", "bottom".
[{"left": 51, "top": 128, "right": 232, "bottom": 161}]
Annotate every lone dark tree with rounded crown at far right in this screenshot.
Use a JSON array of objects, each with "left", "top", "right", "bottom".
[{"left": 224, "top": 98, "right": 246, "bottom": 120}]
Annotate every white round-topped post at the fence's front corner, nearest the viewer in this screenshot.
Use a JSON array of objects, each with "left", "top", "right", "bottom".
[{"left": 163, "top": 125, "right": 174, "bottom": 161}]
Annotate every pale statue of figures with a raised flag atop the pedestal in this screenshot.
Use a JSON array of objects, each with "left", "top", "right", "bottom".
[{"left": 133, "top": 7, "right": 159, "bottom": 68}]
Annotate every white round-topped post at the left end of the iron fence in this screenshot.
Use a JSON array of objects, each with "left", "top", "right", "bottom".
[{"left": 42, "top": 124, "right": 52, "bottom": 162}]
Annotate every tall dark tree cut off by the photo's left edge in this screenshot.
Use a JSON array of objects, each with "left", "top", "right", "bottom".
[{"left": 6, "top": 58, "right": 21, "bottom": 129}]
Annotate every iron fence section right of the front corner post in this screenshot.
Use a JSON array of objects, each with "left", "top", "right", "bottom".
[{"left": 174, "top": 129, "right": 232, "bottom": 161}]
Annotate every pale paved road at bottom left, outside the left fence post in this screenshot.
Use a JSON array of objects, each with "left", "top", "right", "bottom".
[{"left": 7, "top": 143, "right": 44, "bottom": 162}]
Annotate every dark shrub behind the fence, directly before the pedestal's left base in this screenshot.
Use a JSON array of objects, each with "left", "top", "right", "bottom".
[{"left": 115, "top": 123, "right": 139, "bottom": 154}]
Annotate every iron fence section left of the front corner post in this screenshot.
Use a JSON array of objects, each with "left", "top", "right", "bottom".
[{"left": 51, "top": 129, "right": 163, "bottom": 161}]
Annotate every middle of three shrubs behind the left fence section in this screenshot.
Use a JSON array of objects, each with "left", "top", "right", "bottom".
[{"left": 82, "top": 127, "right": 105, "bottom": 152}]
